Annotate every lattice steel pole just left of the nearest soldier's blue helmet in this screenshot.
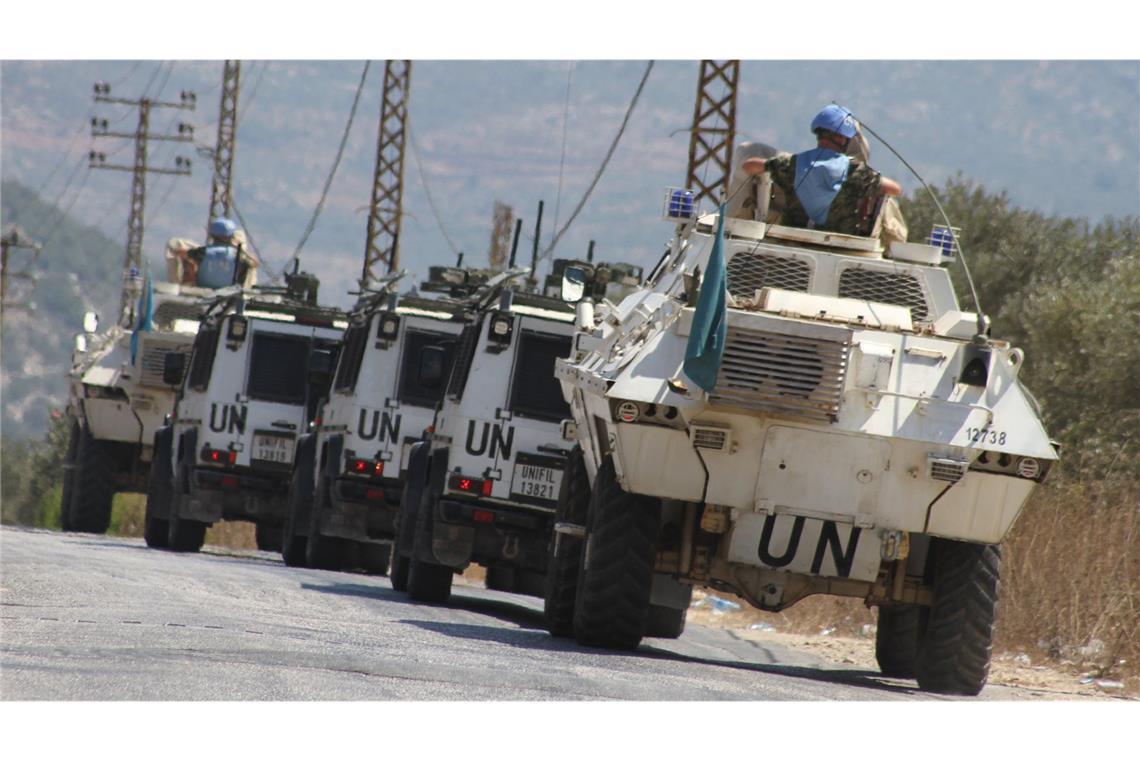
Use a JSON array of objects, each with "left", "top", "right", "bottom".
[{"left": 685, "top": 60, "right": 740, "bottom": 207}]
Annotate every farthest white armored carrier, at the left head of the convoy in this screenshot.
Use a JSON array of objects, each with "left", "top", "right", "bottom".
[{"left": 60, "top": 272, "right": 213, "bottom": 533}]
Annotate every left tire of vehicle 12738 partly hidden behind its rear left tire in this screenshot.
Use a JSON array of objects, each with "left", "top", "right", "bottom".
[{"left": 543, "top": 446, "right": 589, "bottom": 637}]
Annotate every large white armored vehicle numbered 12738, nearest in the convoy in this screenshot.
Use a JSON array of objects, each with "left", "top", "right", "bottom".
[{"left": 546, "top": 187, "right": 1057, "bottom": 694}]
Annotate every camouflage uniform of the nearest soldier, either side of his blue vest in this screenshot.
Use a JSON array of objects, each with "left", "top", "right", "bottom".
[{"left": 764, "top": 155, "right": 881, "bottom": 237}]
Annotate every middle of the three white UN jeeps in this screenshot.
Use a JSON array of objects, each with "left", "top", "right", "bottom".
[{"left": 282, "top": 267, "right": 491, "bottom": 574}]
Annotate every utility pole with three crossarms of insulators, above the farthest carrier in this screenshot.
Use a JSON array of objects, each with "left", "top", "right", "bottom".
[{"left": 88, "top": 82, "right": 197, "bottom": 323}]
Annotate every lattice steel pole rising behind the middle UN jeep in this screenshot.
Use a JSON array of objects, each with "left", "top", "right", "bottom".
[{"left": 360, "top": 60, "right": 412, "bottom": 287}]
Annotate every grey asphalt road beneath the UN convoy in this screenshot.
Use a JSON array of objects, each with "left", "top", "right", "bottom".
[{"left": 0, "top": 526, "right": 1039, "bottom": 701}]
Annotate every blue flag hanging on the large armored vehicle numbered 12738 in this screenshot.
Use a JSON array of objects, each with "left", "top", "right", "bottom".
[{"left": 684, "top": 206, "right": 728, "bottom": 393}]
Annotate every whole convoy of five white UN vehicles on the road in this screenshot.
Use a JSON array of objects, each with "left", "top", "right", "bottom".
[{"left": 63, "top": 109, "right": 1057, "bottom": 694}]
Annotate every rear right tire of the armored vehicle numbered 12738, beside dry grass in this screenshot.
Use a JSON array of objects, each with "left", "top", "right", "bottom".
[{"left": 914, "top": 539, "right": 1001, "bottom": 696}]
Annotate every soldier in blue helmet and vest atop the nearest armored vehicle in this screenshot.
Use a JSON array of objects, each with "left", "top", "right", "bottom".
[{"left": 741, "top": 105, "right": 902, "bottom": 236}]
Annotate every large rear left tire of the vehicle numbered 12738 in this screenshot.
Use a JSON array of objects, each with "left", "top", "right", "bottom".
[{"left": 573, "top": 459, "right": 661, "bottom": 649}]
